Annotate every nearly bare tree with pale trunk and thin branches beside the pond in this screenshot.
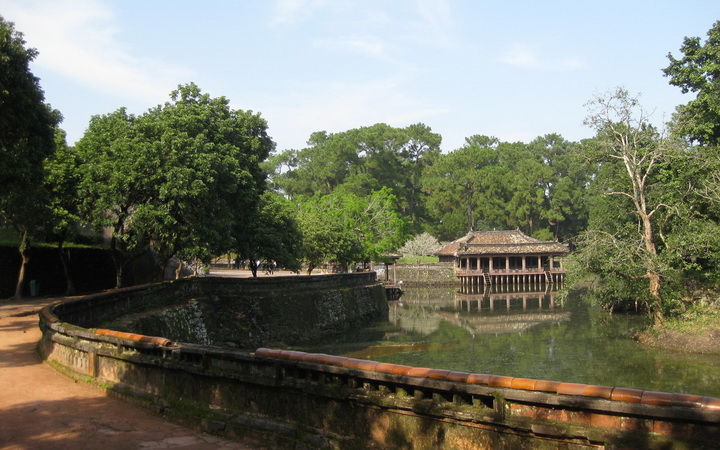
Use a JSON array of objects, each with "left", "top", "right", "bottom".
[{"left": 585, "top": 88, "right": 668, "bottom": 322}]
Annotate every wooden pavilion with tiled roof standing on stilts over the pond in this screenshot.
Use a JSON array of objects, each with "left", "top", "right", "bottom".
[{"left": 436, "top": 230, "right": 570, "bottom": 287}]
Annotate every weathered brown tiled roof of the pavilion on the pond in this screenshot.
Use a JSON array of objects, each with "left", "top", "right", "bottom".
[{"left": 435, "top": 230, "right": 570, "bottom": 256}]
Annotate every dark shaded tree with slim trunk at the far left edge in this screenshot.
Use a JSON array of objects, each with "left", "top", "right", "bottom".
[{"left": 0, "top": 16, "right": 61, "bottom": 297}]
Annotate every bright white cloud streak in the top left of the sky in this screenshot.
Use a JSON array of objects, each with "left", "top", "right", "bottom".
[{"left": 4, "top": 0, "right": 187, "bottom": 102}]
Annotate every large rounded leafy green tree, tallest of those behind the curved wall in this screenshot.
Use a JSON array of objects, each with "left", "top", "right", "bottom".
[{"left": 138, "top": 83, "right": 274, "bottom": 276}]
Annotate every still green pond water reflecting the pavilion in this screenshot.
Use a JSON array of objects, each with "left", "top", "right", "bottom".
[{"left": 297, "top": 287, "right": 720, "bottom": 397}]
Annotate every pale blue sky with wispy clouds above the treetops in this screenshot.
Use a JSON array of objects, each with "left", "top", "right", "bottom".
[{"left": 0, "top": 0, "right": 720, "bottom": 152}]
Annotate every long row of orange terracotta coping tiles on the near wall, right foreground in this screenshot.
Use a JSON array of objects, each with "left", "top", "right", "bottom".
[{"left": 255, "top": 348, "right": 720, "bottom": 411}]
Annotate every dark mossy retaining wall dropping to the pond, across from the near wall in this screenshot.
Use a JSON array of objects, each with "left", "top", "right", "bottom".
[{"left": 64, "top": 273, "right": 388, "bottom": 349}]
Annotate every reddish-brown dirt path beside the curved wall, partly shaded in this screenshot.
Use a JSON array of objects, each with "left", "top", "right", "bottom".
[{"left": 0, "top": 300, "right": 253, "bottom": 450}]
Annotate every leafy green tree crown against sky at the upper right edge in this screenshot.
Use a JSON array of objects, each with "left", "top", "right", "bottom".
[{"left": 663, "top": 21, "right": 720, "bottom": 146}]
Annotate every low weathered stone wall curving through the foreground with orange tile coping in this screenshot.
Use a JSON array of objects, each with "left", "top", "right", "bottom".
[{"left": 39, "top": 278, "right": 720, "bottom": 448}]
